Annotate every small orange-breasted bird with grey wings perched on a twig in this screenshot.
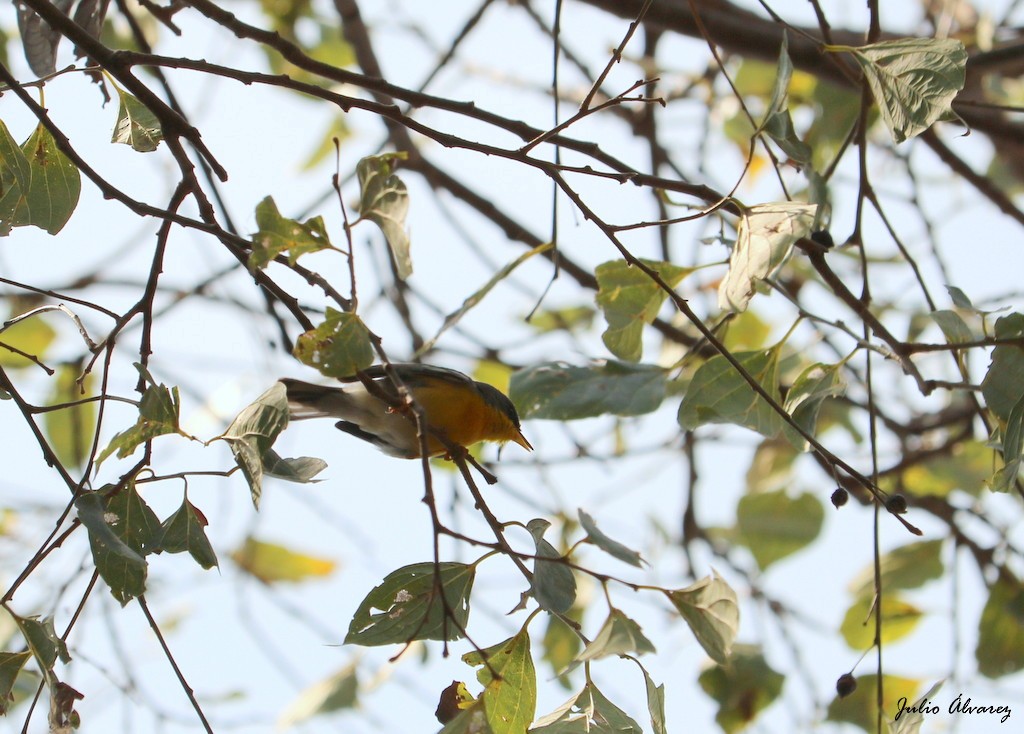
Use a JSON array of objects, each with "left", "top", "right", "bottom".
[{"left": 281, "top": 363, "right": 534, "bottom": 459}]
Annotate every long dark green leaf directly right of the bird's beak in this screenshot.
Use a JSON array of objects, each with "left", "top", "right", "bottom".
[{"left": 509, "top": 361, "right": 666, "bottom": 421}]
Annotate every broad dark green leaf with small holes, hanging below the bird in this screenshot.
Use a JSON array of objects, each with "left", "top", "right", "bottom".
[{"left": 345, "top": 562, "right": 476, "bottom": 646}]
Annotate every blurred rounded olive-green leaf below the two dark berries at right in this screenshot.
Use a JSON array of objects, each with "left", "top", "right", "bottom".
[{"left": 736, "top": 489, "right": 824, "bottom": 570}]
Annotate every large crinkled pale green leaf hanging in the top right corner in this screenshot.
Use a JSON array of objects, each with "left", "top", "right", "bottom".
[{"left": 825, "top": 38, "right": 967, "bottom": 143}]
